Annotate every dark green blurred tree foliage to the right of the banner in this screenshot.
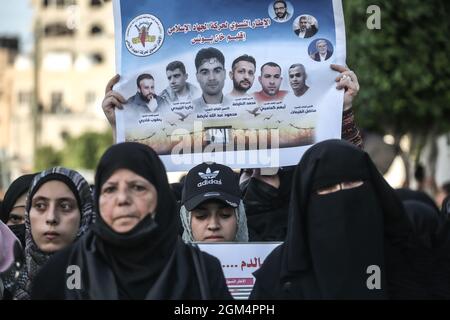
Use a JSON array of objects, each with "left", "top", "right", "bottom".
[{"left": 343, "top": 0, "right": 450, "bottom": 135}]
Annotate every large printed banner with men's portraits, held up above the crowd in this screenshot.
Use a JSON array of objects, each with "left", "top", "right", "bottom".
[{"left": 114, "top": 0, "right": 345, "bottom": 171}]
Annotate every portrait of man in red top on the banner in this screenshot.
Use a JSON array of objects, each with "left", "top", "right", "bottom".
[{"left": 253, "top": 62, "right": 287, "bottom": 103}]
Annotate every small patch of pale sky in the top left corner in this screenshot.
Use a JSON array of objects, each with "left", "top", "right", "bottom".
[{"left": 0, "top": 0, "right": 33, "bottom": 52}]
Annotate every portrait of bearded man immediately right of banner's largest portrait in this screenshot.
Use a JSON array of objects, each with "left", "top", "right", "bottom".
[{"left": 229, "top": 54, "right": 256, "bottom": 98}]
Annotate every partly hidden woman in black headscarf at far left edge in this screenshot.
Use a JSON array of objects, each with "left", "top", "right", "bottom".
[{"left": 0, "top": 174, "right": 35, "bottom": 248}]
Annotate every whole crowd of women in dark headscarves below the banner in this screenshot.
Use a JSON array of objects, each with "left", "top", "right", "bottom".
[{"left": 0, "top": 66, "right": 450, "bottom": 300}]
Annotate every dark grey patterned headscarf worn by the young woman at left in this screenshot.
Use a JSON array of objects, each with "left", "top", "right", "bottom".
[{"left": 13, "top": 167, "right": 95, "bottom": 300}]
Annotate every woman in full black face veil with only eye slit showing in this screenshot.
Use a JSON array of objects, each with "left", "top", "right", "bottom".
[{"left": 251, "top": 140, "right": 412, "bottom": 299}]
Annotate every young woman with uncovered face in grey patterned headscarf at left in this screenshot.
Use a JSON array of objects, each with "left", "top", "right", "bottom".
[{"left": 13, "top": 167, "right": 94, "bottom": 300}]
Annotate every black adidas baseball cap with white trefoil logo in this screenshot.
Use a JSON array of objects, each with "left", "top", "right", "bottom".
[{"left": 181, "top": 163, "right": 241, "bottom": 211}]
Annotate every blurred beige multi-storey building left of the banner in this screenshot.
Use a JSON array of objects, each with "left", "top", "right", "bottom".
[{"left": 0, "top": 0, "right": 115, "bottom": 187}]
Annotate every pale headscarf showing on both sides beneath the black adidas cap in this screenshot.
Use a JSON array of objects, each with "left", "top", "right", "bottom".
[{"left": 180, "top": 200, "right": 248, "bottom": 243}]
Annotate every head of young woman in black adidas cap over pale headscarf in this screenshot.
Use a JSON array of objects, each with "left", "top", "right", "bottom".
[{"left": 180, "top": 163, "right": 248, "bottom": 243}]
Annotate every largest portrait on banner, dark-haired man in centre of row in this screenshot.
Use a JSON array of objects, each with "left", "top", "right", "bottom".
[{"left": 192, "top": 47, "right": 231, "bottom": 112}]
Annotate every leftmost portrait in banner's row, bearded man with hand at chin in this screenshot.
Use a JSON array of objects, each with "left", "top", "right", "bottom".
[{"left": 127, "top": 73, "right": 167, "bottom": 115}]
